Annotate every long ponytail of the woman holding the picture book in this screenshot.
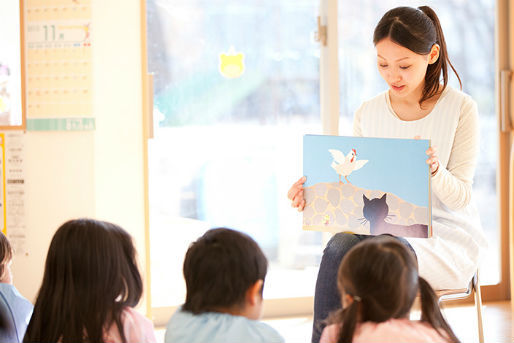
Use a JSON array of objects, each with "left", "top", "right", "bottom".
[{"left": 418, "top": 6, "right": 462, "bottom": 105}]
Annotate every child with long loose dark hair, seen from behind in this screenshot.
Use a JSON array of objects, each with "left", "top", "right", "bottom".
[{"left": 24, "top": 219, "right": 156, "bottom": 343}]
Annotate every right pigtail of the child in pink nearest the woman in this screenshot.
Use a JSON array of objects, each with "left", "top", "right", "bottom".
[{"left": 418, "top": 277, "right": 460, "bottom": 343}]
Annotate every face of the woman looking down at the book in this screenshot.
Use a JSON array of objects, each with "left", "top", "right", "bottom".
[{"left": 375, "top": 38, "right": 429, "bottom": 99}]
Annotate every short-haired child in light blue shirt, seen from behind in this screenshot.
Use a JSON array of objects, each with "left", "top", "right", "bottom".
[{"left": 165, "top": 228, "right": 284, "bottom": 343}]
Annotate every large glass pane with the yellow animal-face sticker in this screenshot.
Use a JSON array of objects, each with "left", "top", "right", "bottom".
[{"left": 147, "top": 0, "right": 322, "bottom": 307}]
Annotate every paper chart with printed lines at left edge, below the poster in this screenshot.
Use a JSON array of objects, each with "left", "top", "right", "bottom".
[{"left": 0, "top": 131, "right": 27, "bottom": 254}]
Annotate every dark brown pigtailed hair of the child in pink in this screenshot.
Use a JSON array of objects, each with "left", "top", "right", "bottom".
[{"left": 329, "top": 236, "right": 459, "bottom": 343}]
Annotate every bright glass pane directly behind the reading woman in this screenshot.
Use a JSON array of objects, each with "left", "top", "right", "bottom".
[{"left": 339, "top": 0, "right": 500, "bottom": 284}]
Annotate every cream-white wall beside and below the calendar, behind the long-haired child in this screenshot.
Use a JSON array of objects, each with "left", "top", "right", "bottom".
[{"left": 13, "top": 0, "right": 144, "bottom": 301}]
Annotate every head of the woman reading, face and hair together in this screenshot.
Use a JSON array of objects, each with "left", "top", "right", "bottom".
[{"left": 373, "top": 6, "right": 462, "bottom": 104}]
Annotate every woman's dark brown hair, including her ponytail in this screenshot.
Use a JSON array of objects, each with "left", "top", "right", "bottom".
[{"left": 373, "top": 6, "right": 462, "bottom": 105}]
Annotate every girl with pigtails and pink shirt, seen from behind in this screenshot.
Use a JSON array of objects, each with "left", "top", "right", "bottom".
[{"left": 320, "top": 236, "right": 458, "bottom": 343}]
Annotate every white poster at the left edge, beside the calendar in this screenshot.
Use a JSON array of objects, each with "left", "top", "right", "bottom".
[{"left": 0, "top": 1, "right": 23, "bottom": 129}]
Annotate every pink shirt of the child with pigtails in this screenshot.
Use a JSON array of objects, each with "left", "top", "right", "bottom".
[{"left": 320, "top": 319, "right": 449, "bottom": 343}]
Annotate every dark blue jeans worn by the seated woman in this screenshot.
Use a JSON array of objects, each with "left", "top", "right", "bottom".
[{"left": 312, "top": 233, "right": 414, "bottom": 343}]
